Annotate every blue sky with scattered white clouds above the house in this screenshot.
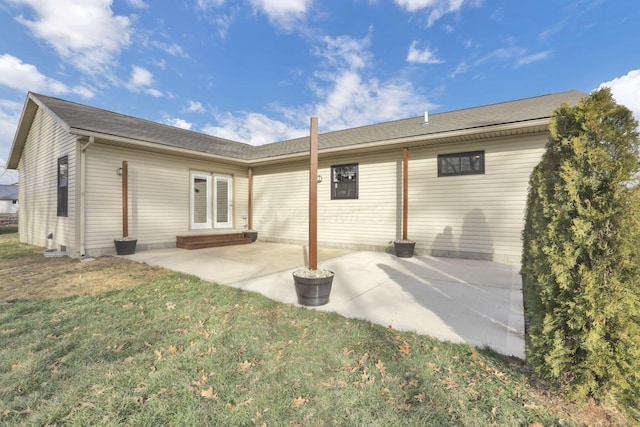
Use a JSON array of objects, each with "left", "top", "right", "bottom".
[{"left": 0, "top": 0, "right": 640, "bottom": 181}]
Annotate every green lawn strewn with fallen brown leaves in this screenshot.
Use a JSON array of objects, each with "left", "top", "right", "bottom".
[{"left": 0, "top": 233, "right": 620, "bottom": 426}]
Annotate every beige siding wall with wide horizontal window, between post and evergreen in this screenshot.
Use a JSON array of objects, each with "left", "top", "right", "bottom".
[{"left": 409, "top": 135, "right": 547, "bottom": 263}]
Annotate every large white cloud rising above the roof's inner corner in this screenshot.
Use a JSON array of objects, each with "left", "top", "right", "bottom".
[{"left": 204, "top": 31, "right": 434, "bottom": 145}]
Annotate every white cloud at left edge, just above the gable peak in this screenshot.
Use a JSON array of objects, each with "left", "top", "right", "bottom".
[{"left": 0, "top": 54, "right": 94, "bottom": 98}]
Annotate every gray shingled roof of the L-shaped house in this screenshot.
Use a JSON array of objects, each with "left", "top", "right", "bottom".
[{"left": 32, "top": 90, "right": 585, "bottom": 161}]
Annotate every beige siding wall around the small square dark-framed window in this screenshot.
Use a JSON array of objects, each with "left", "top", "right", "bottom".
[{"left": 253, "top": 151, "right": 402, "bottom": 249}]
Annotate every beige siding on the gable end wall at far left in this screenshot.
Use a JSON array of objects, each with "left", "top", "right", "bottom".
[{"left": 18, "top": 109, "right": 77, "bottom": 253}]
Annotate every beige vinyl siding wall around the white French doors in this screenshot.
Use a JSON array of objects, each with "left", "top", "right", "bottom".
[{"left": 85, "top": 143, "right": 248, "bottom": 255}]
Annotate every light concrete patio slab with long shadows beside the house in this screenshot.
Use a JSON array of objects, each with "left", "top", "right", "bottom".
[{"left": 127, "top": 241, "right": 524, "bottom": 358}]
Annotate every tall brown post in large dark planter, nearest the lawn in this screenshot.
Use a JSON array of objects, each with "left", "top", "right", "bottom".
[{"left": 293, "top": 117, "right": 335, "bottom": 306}]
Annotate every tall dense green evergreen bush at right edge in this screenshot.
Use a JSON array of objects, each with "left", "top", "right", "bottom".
[{"left": 522, "top": 88, "right": 640, "bottom": 407}]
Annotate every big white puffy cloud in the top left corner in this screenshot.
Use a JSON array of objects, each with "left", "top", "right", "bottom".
[{"left": 10, "top": 0, "right": 133, "bottom": 74}]
